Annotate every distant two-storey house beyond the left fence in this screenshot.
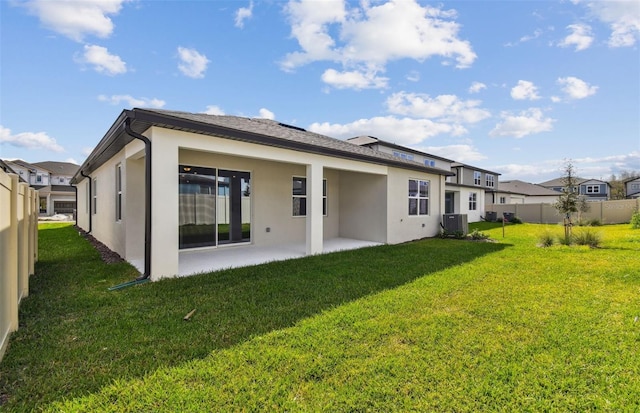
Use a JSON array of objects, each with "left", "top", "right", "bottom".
[{"left": 5, "top": 160, "right": 79, "bottom": 216}]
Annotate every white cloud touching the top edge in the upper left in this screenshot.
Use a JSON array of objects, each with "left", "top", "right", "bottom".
[{"left": 24, "top": 0, "right": 128, "bottom": 42}]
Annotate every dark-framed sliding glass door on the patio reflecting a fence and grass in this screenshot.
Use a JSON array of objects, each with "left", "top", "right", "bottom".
[{"left": 179, "top": 165, "right": 251, "bottom": 249}]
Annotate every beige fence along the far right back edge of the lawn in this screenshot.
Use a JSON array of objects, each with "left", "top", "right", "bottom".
[{"left": 486, "top": 199, "right": 640, "bottom": 224}]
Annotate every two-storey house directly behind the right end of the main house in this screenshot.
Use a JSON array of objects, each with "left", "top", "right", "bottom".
[{"left": 347, "top": 136, "right": 500, "bottom": 222}]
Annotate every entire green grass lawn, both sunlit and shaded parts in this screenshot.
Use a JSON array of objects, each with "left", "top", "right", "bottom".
[{"left": 0, "top": 223, "right": 640, "bottom": 412}]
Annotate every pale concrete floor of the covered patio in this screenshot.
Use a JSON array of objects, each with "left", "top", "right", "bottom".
[{"left": 178, "top": 238, "right": 382, "bottom": 277}]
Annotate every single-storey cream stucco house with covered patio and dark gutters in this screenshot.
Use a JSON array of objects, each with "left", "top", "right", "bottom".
[{"left": 72, "top": 109, "right": 451, "bottom": 280}]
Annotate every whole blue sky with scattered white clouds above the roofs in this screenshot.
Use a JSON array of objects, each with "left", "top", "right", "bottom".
[{"left": 0, "top": 0, "right": 640, "bottom": 182}]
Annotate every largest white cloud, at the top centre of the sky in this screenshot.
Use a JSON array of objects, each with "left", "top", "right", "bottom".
[{"left": 281, "top": 0, "right": 476, "bottom": 87}]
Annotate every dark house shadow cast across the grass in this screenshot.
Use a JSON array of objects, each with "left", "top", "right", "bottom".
[{"left": 0, "top": 226, "right": 506, "bottom": 411}]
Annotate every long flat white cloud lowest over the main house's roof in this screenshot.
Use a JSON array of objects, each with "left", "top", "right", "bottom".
[{"left": 307, "top": 116, "right": 464, "bottom": 146}]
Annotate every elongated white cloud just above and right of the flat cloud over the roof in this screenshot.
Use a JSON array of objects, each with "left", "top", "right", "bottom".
[{"left": 386, "top": 92, "right": 491, "bottom": 123}]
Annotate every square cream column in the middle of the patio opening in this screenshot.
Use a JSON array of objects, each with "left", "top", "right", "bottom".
[{"left": 307, "top": 163, "right": 324, "bottom": 255}]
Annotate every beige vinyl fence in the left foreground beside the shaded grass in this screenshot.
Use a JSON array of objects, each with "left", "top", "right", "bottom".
[{"left": 0, "top": 170, "right": 38, "bottom": 361}]
